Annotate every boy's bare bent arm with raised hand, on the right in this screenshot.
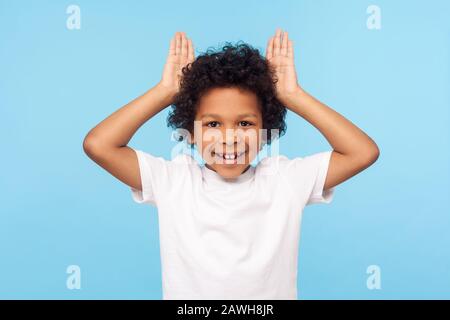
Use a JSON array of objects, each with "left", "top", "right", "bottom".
[{"left": 266, "top": 29, "right": 380, "bottom": 190}]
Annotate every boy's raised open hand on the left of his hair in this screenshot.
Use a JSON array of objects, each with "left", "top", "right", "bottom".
[{"left": 159, "top": 32, "right": 195, "bottom": 94}]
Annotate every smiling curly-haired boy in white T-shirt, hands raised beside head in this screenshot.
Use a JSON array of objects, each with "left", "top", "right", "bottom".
[{"left": 83, "top": 29, "right": 379, "bottom": 299}]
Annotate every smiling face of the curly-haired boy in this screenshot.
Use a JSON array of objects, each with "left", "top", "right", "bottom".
[{"left": 193, "top": 87, "right": 263, "bottom": 179}]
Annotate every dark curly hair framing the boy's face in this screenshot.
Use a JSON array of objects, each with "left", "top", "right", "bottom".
[{"left": 167, "top": 41, "right": 286, "bottom": 147}]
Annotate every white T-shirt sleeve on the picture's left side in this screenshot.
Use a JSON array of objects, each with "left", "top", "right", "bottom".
[{"left": 131, "top": 149, "right": 168, "bottom": 206}]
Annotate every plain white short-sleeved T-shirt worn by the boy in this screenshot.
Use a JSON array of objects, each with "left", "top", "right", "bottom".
[{"left": 131, "top": 149, "right": 334, "bottom": 300}]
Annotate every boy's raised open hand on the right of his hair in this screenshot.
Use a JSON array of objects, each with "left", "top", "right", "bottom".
[{"left": 266, "top": 28, "right": 301, "bottom": 104}]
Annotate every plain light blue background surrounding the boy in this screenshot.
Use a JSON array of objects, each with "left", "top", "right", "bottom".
[{"left": 0, "top": 0, "right": 450, "bottom": 299}]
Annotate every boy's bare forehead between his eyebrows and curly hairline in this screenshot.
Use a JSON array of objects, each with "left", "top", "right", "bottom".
[{"left": 197, "top": 87, "right": 261, "bottom": 118}]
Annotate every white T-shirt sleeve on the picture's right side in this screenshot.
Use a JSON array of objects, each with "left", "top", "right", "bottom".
[{"left": 282, "top": 150, "right": 335, "bottom": 205}]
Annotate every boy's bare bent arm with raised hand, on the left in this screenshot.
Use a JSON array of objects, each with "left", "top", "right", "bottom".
[{"left": 83, "top": 32, "right": 194, "bottom": 190}]
